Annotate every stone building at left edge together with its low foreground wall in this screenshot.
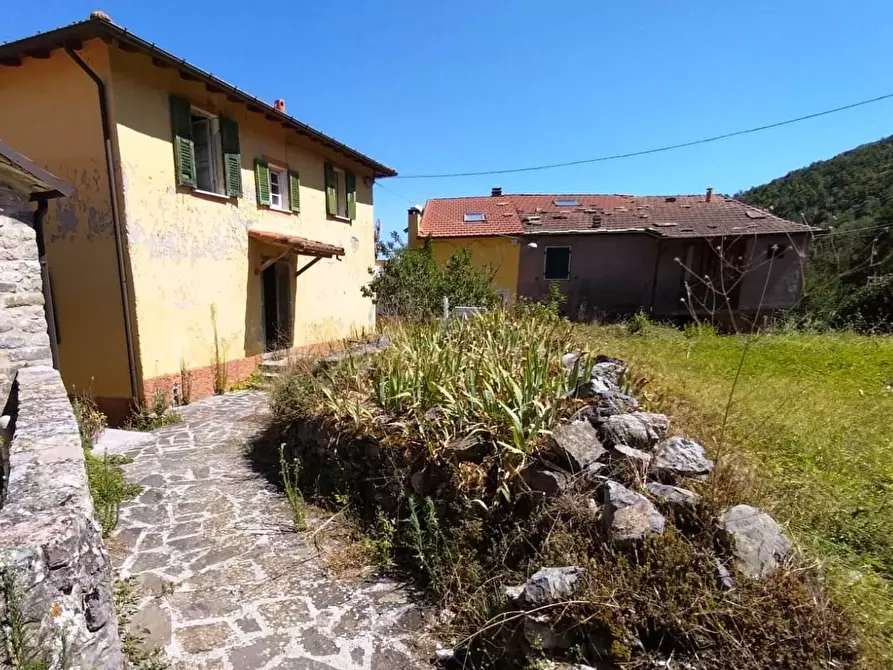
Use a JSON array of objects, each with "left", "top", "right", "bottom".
[{"left": 0, "top": 140, "right": 124, "bottom": 670}]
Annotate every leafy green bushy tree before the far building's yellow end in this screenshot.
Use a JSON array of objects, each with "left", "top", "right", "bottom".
[{"left": 362, "top": 233, "right": 499, "bottom": 320}]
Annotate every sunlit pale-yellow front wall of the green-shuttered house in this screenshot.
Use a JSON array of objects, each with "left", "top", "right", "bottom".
[{"left": 111, "top": 50, "right": 375, "bottom": 386}]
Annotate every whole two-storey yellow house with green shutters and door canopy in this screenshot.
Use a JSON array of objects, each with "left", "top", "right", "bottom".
[{"left": 0, "top": 12, "right": 396, "bottom": 420}]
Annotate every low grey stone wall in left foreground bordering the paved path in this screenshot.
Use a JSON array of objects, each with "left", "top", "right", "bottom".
[{"left": 0, "top": 364, "right": 124, "bottom": 670}]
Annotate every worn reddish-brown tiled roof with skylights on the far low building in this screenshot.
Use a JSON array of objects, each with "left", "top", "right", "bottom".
[{"left": 419, "top": 194, "right": 812, "bottom": 237}]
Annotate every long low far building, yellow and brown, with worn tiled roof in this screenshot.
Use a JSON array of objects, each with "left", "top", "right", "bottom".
[{"left": 409, "top": 189, "right": 811, "bottom": 323}]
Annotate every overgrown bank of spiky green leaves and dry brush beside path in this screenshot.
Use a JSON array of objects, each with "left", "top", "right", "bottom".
[{"left": 251, "top": 308, "right": 863, "bottom": 669}]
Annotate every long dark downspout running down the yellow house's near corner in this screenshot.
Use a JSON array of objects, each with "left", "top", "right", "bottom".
[{"left": 65, "top": 47, "right": 139, "bottom": 405}]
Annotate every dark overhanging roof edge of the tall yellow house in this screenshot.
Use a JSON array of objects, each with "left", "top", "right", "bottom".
[{"left": 0, "top": 17, "right": 397, "bottom": 177}]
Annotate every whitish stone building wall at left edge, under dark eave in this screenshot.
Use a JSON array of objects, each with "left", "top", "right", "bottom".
[{"left": 0, "top": 210, "right": 52, "bottom": 407}]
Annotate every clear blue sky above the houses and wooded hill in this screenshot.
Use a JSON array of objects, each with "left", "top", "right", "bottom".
[{"left": 0, "top": 0, "right": 893, "bottom": 239}]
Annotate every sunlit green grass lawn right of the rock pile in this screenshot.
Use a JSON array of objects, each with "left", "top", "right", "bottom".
[{"left": 587, "top": 326, "right": 893, "bottom": 667}]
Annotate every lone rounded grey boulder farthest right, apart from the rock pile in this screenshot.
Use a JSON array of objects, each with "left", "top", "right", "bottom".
[{"left": 719, "top": 505, "right": 791, "bottom": 579}]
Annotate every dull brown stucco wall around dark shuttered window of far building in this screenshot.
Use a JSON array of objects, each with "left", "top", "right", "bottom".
[{"left": 518, "top": 233, "right": 657, "bottom": 318}]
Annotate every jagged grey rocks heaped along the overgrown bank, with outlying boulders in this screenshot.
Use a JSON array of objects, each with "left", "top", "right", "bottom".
[{"left": 506, "top": 354, "right": 791, "bottom": 650}]
